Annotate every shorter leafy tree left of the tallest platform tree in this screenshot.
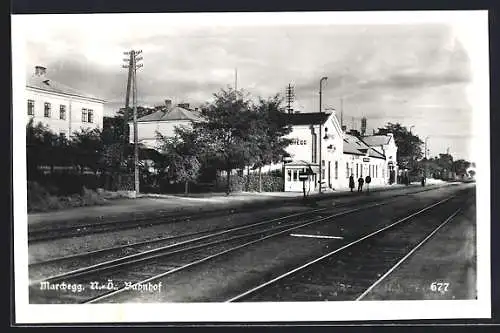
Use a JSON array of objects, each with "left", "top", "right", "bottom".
[{"left": 156, "top": 127, "right": 201, "bottom": 194}]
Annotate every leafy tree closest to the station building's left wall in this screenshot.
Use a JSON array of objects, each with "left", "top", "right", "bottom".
[{"left": 253, "top": 94, "right": 292, "bottom": 192}]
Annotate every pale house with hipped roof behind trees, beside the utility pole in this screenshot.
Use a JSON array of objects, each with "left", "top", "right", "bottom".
[{"left": 129, "top": 100, "right": 201, "bottom": 149}]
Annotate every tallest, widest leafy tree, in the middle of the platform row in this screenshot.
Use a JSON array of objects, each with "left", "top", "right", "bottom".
[{"left": 194, "top": 88, "right": 257, "bottom": 194}]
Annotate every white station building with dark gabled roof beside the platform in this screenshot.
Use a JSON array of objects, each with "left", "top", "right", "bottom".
[{"left": 284, "top": 112, "right": 397, "bottom": 192}]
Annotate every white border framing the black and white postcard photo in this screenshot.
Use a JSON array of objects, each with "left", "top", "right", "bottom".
[{"left": 12, "top": 10, "right": 491, "bottom": 323}]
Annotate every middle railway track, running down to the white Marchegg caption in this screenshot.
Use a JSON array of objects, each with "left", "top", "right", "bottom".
[{"left": 30, "top": 185, "right": 470, "bottom": 303}]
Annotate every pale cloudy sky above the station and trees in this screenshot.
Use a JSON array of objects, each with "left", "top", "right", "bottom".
[{"left": 16, "top": 13, "right": 487, "bottom": 160}]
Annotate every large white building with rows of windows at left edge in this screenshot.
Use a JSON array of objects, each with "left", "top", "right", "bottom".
[{"left": 25, "top": 66, "right": 105, "bottom": 137}]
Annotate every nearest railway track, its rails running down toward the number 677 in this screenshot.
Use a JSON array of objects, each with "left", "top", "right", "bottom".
[{"left": 226, "top": 189, "right": 471, "bottom": 302}]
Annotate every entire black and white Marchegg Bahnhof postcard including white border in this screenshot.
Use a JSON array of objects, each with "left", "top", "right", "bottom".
[{"left": 12, "top": 11, "right": 491, "bottom": 324}]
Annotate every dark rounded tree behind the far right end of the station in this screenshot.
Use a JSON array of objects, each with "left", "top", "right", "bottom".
[{"left": 375, "top": 122, "right": 423, "bottom": 170}]
